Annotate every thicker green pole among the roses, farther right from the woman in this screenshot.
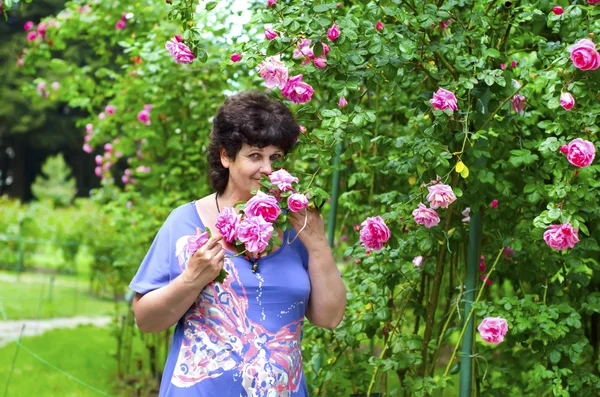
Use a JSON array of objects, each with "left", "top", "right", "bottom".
[{"left": 459, "top": 210, "right": 481, "bottom": 397}]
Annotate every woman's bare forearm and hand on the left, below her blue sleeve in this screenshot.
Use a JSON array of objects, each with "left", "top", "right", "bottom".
[{"left": 133, "top": 235, "right": 225, "bottom": 332}]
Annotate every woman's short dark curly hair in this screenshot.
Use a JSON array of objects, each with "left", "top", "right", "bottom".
[{"left": 208, "top": 91, "right": 300, "bottom": 193}]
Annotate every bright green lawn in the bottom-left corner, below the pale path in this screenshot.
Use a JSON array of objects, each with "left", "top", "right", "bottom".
[{"left": 0, "top": 326, "right": 124, "bottom": 397}]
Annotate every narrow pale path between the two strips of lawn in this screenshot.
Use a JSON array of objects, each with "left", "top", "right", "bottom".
[{"left": 0, "top": 316, "right": 112, "bottom": 347}]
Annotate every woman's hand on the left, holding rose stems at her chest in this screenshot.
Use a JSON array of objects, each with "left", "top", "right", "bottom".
[{"left": 182, "top": 234, "right": 225, "bottom": 287}]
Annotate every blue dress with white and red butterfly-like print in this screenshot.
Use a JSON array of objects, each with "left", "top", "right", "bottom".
[{"left": 129, "top": 202, "right": 310, "bottom": 397}]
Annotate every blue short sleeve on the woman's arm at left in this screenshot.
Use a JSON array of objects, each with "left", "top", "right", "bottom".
[{"left": 129, "top": 216, "right": 176, "bottom": 294}]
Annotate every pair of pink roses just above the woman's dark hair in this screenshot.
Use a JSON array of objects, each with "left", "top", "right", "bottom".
[{"left": 258, "top": 58, "right": 315, "bottom": 103}]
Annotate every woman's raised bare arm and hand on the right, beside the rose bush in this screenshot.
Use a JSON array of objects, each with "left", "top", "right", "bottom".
[{"left": 290, "top": 210, "right": 346, "bottom": 328}]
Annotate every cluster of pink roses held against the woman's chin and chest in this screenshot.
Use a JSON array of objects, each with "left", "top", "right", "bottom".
[{"left": 215, "top": 169, "right": 308, "bottom": 254}]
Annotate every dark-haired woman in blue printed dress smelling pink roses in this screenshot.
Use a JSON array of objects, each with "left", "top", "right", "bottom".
[{"left": 130, "top": 92, "right": 346, "bottom": 397}]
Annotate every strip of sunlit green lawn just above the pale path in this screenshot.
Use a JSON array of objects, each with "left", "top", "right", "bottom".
[{"left": 0, "top": 271, "right": 125, "bottom": 320}]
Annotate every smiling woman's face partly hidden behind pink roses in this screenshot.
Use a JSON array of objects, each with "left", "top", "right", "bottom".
[{"left": 221, "top": 143, "right": 284, "bottom": 193}]
